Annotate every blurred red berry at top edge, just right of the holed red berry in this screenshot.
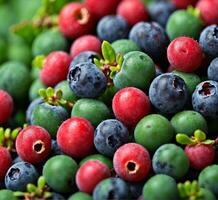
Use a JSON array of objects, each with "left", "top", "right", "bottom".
[{"left": 85, "top": 0, "right": 121, "bottom": 19}]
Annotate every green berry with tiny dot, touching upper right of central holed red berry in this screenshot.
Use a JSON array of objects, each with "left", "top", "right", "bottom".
[{"left": 134, "top": 114, "right": 174, "bottom": 151}]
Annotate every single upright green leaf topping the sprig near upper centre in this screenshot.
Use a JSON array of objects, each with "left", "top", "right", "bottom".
[{"left": 102, "top": 41, "right": 116, "bottom": 64}]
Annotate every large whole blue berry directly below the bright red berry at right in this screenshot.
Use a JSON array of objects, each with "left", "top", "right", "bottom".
[{"left": 149, "top": 73, "right": 188, "bottom": 114}]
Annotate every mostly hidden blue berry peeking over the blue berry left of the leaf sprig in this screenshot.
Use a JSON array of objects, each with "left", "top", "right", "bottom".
[{"left": 69, "top": 51, "right": 100, "bottom": 69}]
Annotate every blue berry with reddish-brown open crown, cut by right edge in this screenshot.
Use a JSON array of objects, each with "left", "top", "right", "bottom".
[{"left": 192, "top": 81, "right": 218, "bottom": 117}]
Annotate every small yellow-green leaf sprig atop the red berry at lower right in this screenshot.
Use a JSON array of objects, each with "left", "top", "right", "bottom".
[{"left": 176, "top": 130, "right": 215, "bottom": 145}]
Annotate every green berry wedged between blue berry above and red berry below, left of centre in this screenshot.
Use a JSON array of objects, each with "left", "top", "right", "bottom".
[{"left": 71, "top": 99, "right": 110, "bottom": 126}]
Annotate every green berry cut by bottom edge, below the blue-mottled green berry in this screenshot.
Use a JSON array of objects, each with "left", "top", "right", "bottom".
[{"left": 143, "top": 174, "right": 179, "bottom": 200}]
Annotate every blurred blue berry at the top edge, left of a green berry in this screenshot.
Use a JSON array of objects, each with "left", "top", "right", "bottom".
[{"left": 148, "top": 1, "right": 176, "bottom": 27}]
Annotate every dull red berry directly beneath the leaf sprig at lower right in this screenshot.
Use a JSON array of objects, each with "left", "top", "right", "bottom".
[{"left": 185, "top": 144, "right": 215, "bottom": 170}]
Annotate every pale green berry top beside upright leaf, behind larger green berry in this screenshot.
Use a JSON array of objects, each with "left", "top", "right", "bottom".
[{"left": 111, "top": 39, "right": 140, "bottom": 55}]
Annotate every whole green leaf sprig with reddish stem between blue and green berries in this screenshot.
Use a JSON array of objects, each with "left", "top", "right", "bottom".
[{"left": 94, "top": 41, "right": 123, "bottom": 85}]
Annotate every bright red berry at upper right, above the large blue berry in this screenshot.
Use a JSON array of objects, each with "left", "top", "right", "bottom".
[{"left": 167, "top": 37, "right": 203, "bottom": 72}]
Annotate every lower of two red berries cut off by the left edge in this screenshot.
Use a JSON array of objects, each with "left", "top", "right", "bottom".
[{"left": 0, "top": 146, "right": 12, "bottom": 180}]
